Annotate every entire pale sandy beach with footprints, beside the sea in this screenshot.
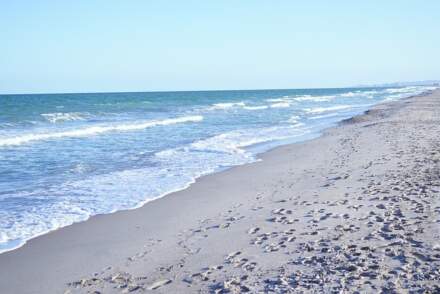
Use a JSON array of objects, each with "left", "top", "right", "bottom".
[{"left": 0, "top": 91, "right": 440, "bottom": 294}]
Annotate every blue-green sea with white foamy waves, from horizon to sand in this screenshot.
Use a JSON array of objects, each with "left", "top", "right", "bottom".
[{"left": 0, "top": 87, "right": 432, "bottom": 252}]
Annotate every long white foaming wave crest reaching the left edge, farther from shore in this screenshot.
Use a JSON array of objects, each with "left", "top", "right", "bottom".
[{"left": 0, "top": 115, "right": 203, "bottom": 146}]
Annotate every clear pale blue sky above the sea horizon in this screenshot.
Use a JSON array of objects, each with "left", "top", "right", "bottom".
[{"left": 0, "top": 0, "right": 440, "bottom": 94}]
